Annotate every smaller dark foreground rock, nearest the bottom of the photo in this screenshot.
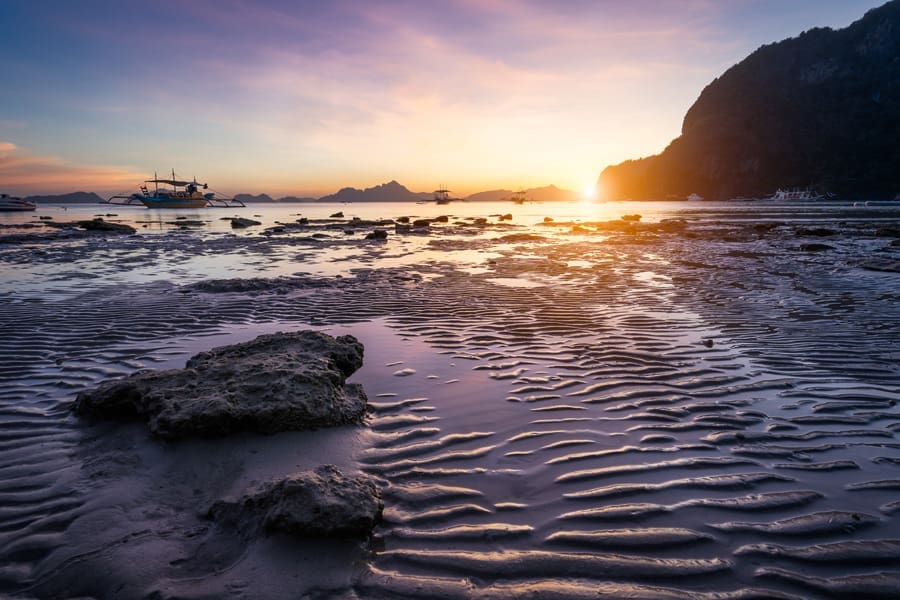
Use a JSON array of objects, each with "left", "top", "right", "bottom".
[{"left": 208, "top": 465, "right": 384, "bottom": 538}]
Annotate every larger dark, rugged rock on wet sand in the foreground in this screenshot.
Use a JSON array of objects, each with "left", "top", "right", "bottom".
[{"left": 73, "top": 331, "right": 366, "bottom": 438}]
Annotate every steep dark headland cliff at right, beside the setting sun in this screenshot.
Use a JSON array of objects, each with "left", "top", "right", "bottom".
[{"left": 598, "top": 0, "right": 900, "bottom": 200}]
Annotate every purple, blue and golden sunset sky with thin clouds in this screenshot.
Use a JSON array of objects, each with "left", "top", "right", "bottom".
[{"left": 0, "top": 0, "right": 883, "bottom": 197}]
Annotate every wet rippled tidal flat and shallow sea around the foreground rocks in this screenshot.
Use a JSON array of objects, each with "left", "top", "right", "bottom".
[{"left": 0, "top": 203, "right": 900, "bottom": 598}]
